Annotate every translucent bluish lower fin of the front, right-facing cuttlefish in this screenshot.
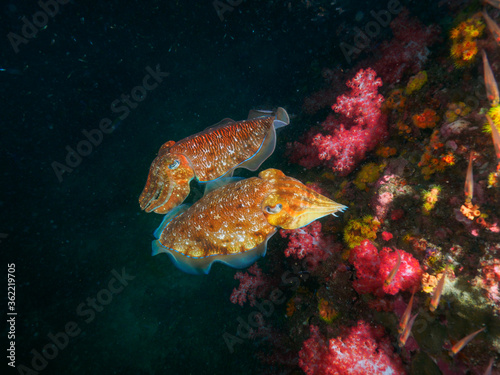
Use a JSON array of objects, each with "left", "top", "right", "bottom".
[{"left": 152, "top": 231, "right": 276, "bottom": 275}]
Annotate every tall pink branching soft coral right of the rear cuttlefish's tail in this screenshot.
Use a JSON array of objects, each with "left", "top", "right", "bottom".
[{"left": 289, "top": 69, "right": 387, "bottom": 175}]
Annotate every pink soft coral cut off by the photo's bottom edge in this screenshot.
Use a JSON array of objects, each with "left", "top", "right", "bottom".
[{"left": 299, "top": 320, "right": 405, "bottom": 375}]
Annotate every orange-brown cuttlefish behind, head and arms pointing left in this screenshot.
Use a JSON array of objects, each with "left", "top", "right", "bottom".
[{"left": 139, "top": 107, "right": 290, "bottom": 214}]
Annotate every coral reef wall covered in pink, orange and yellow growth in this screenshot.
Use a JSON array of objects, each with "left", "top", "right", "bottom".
[{"left": 229, "top": 0, "right": 500, "bottom": 374}]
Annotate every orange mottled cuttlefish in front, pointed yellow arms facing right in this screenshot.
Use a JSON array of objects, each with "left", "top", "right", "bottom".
[{"left": 153, "top": 169, "right": 347, "bottom": 274}]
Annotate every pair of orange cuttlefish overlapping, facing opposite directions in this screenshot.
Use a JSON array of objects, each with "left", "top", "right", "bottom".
[{"left": 139, "top": 108, "right": 347, "bottom": 274}]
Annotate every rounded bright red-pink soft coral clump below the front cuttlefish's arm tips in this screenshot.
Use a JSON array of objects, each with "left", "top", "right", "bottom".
[{"left": 349, "top": 240, "right": 422, "bottom": 297}]
